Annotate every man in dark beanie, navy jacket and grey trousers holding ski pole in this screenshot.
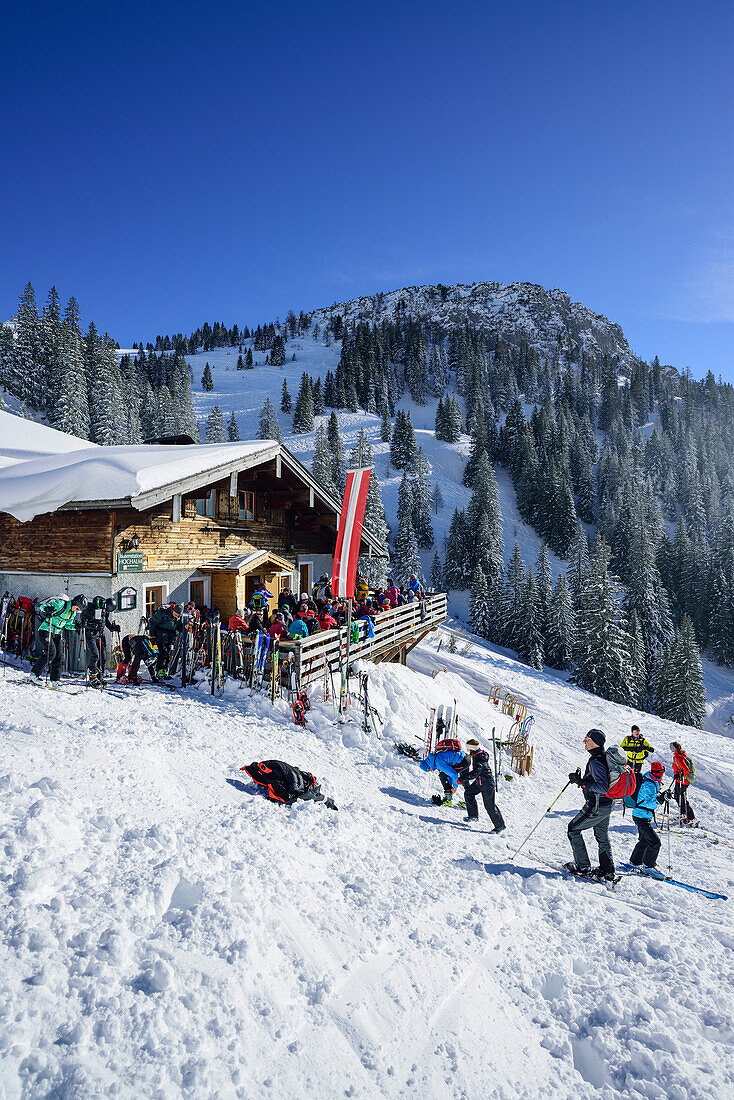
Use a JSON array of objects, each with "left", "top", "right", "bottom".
[{"left": 563, "top": 729, "right": 614, "bottom": 881}]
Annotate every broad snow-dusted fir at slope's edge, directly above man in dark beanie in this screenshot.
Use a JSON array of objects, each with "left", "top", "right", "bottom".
[{"left": 571, "top": 537, "right": 635, "bottom": 704}]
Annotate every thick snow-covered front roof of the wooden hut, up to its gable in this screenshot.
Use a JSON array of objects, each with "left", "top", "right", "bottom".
[{"left": 0, "top": 437, "right": 280, "bottom": 523}]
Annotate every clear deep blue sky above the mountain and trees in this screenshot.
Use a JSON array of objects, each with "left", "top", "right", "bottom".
[{"left": 0, "top": 0, "right": 734, "bottom": 381}]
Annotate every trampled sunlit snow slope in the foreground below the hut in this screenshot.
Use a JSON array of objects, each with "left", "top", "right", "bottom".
[{"left": 0, "top": 630, "right": 734, "bottom": 1100}]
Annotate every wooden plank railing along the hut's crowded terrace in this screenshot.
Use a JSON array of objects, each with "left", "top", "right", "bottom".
[{"left": 295, "top": 592, "right": 447, "bottom": 688}]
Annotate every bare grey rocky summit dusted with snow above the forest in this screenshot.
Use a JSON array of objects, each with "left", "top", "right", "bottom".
[{"left": 310, "top": 283, "right": 636, "bottom": 366}]
